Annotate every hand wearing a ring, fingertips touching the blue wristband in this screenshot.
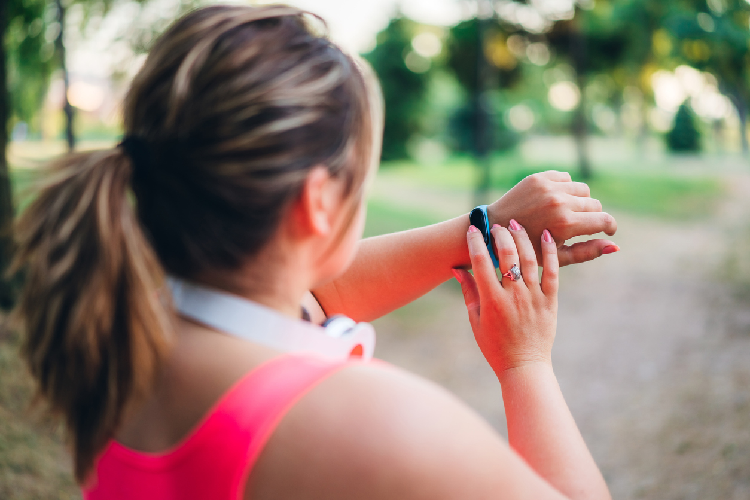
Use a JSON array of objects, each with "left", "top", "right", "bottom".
[{"left": 454, "top": 220, "right": 559, "bottom": 376}]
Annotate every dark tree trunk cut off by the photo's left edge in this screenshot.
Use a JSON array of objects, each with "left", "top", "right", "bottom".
[{"left": 0, "top": 2, "right": 15, "bottom": 310}]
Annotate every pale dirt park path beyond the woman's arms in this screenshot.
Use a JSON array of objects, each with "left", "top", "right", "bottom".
[{"left": 376, "top": 171, "right": 750, "bottom": 500}]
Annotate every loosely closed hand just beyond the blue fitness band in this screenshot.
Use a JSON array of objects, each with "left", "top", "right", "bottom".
[{"left": 487, "top": 170, "right": 620, "bottom": 266}]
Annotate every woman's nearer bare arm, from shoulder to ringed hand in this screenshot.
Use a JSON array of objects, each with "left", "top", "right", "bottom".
[{"left": 246, "top": 227, "right": 610, "bottom": 500}]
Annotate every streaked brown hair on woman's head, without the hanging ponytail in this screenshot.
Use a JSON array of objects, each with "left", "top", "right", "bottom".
[{"left": 124, "top": 2, "right": 380, "bottom": 278}]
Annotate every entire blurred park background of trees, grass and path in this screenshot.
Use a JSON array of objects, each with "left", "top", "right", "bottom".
[{"left": 0, "top": 0, "right": 750, "bottom": 499}]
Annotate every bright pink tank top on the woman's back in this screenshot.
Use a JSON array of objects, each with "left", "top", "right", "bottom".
[{"left": 83, "top": 355, "right": 346, "bottom": 500}]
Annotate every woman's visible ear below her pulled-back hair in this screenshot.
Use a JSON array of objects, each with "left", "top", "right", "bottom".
[{"left": 292, "top": 166, "right": 341, "bottom": 236}]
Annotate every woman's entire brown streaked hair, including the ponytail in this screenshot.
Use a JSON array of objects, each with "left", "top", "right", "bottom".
[{"left": 14, "top": 5, "right": 382, "bottom": 482}]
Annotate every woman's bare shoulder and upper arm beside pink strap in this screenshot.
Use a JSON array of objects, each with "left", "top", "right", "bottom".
[{"left": 245, "top": 364, "right": 562, "bottom": 500}]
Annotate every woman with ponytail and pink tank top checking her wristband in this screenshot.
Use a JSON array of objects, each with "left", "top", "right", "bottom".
[{"left": 17, "top": 6, "right": 616, "bottom": 499}]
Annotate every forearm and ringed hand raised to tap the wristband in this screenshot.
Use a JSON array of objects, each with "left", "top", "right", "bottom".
[{"left": 456, "top": 221, "right": 609, "bottom": 498}]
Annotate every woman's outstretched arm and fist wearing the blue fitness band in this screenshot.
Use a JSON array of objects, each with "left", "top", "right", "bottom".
[{"left": 306, "top": 171, "right": 619, "bottom": 321}]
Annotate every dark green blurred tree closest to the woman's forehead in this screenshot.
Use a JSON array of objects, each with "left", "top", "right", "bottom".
[{"left": 364, "top": 17, "right": 430, "bottom": 160}]
